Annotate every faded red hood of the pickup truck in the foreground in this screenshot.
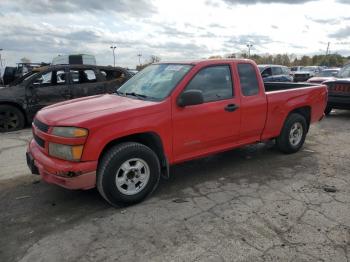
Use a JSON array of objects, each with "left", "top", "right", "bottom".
[{"left": 36, "top": 94, "right": 158, "bottom": 126}]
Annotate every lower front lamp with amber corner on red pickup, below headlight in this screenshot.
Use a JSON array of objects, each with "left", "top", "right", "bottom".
[{"left": 49, "top": 143, "right": 84, "bottom": 161}]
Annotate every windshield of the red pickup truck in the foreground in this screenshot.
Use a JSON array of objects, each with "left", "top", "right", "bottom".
[{"left": 117, "top": 64, "right": 192, "bottom": 100}]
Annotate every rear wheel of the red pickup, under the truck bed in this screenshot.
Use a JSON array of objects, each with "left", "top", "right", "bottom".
[{"left": 276, "top": 113, "right": 307, "bottom": 154}]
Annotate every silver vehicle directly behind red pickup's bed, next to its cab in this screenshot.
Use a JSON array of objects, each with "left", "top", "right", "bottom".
[{"left": 258, "top": 65, "right": 293, "bottom": 82}]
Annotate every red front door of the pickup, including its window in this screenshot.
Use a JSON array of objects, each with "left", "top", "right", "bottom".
[{"left": 173, "top": 64, "right": 240, "bottom": 161}]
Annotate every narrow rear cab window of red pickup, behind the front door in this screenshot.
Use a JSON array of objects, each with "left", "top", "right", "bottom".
[{"left": 238, "top": 63, "right": 259, "bottom": 96}]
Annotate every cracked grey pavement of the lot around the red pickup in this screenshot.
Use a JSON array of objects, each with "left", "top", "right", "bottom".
[{"left": 0, "top": 110, "right": 350, "bottom": 262}]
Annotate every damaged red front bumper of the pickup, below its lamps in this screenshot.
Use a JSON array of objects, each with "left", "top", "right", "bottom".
[{"left": 26, "top": 140, "right": 97, "bottom": 190}]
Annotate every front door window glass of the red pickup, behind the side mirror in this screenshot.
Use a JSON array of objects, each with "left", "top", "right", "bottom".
[{"left": 186, "top": 65, "right": 233, "bottom": 102}]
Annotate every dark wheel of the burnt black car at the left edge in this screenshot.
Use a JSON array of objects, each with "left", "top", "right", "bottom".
[{"left": 0, "top": 105, "right": 25, "bottom": 132}]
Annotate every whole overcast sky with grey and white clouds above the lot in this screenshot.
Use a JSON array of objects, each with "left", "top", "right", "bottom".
[{"left": 0, "top": 0, "right": 350, "bottom": 68}]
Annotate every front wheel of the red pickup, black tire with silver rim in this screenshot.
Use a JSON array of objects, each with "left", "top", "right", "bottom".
[{"left": 96, "top": 142, "right": 161, "bottom": 207}]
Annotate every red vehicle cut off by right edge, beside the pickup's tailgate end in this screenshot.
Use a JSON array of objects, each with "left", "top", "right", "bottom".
[{"left": 324, "top": 64, "right": 350, "bottom": 115}]
